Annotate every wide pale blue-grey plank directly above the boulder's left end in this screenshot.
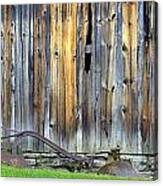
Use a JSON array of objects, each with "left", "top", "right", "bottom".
[{"left": 111, "top": 3, "right": 123, "bottom": 150}]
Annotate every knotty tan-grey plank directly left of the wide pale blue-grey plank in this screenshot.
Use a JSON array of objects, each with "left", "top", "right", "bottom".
[{"left": 101, "top": 2, "right": 117, "bottom": 148}]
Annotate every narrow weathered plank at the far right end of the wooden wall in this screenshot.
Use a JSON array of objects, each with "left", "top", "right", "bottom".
[{"left": 151, "top": 2, "right": 158, "bottom": 154}]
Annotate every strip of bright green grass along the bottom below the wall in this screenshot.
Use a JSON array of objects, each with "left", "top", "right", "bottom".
[{"left": 1, "top": 164, "right": 146, "bottom": 181}]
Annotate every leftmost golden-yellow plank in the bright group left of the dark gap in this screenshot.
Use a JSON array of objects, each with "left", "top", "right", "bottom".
[{"left": 50, "top": 4, "right": 59, "bottom": 144}]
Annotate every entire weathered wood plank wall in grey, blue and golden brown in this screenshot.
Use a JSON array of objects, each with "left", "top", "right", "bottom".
[{"left": 1, "top": 2, "right": 157, "bottom": 153}]
